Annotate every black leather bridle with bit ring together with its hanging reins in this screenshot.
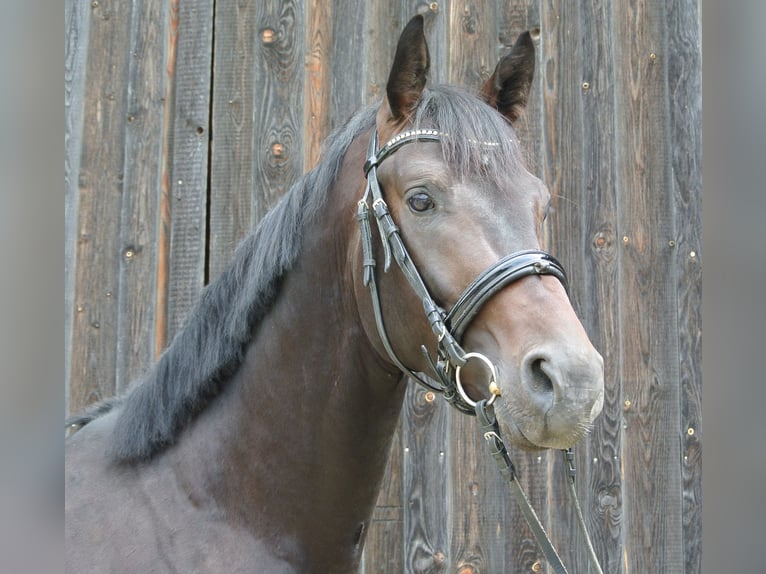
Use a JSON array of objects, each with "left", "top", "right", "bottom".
[{"left": 357, "top": 129, "right": 602, "bottom": 574}]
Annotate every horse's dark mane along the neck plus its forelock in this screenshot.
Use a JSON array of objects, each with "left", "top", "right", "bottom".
[{"left": 97, "top": 86, "right": 520, "bottom": 462}]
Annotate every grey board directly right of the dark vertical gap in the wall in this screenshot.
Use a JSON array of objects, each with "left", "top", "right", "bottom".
[{"left": 208, "top": 0, "right": 260, "bottom": 281}]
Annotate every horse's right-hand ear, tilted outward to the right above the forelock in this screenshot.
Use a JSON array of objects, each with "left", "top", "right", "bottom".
[{"left": 481, "top": 32, "right": 535, "bottom": 122}]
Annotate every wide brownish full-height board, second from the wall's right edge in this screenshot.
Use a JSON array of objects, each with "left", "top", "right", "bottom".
[{"left": 613, "top": 1, "right": 684, "bottom": 572}]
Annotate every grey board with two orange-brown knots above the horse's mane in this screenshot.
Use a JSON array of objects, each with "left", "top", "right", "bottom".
[{"left": 252, "top": 0, "right": 306, "bottom": 224}]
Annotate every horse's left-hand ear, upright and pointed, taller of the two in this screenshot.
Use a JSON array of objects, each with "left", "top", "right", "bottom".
[{"left": 386, "top": 15, "right": 430, "bottom": 122}]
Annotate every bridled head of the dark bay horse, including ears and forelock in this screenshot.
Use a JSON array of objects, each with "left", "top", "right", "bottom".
[{"left": 357, "top": 17, "right": 604, "bottom": 449}]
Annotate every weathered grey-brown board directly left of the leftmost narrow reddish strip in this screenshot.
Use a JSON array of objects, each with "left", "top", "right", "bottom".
[{"left": 115, "top": 0, "right": 168, "bottom": 393}]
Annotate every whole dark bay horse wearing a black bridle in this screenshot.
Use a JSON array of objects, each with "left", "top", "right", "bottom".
[{"left": 66, "top": 17, "right": 603, "bottom": 573}]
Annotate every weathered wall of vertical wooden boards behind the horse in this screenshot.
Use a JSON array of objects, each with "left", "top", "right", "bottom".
[{"left": 65, "top": 0, "right": 702, "bottom": 574}]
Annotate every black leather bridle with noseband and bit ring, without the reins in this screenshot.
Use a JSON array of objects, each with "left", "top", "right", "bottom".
[{"left": 357, "top": 129, "right": 568, "bottom": 415}]
